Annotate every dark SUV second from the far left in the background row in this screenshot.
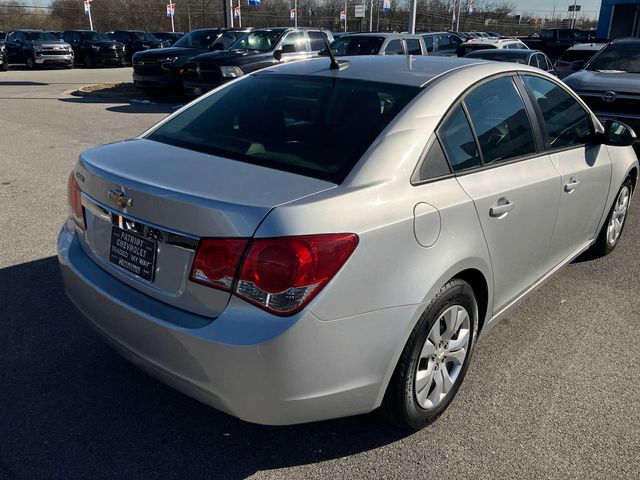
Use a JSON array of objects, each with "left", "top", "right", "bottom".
[{"left": 62, "top": 30, "right": 125, "bottom": 68}]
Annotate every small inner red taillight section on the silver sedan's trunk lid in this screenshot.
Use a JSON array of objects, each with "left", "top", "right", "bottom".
[{"left": 190, "top": 238, "right": 248, "bottom": 291}]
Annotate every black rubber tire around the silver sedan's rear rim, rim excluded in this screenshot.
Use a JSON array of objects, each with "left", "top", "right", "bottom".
[{"left": 379, "top": 279, "right": 478, "bottom": 431}]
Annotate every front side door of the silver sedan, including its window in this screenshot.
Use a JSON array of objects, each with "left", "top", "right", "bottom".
[{"left": 522, "top": 75, "right": 611, "bottom": 268}]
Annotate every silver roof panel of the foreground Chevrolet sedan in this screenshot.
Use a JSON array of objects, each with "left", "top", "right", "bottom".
[{"left": 252, "top": 55, "right": 487, "bottom": 87}]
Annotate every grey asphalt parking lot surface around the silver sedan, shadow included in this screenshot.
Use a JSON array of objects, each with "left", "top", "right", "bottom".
[{"left": 0, "top": 69, "right": 640, "bottom": 479}]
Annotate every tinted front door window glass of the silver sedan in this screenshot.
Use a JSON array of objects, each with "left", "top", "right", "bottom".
[{"left": 523, "top": 75, "right": 592, "bottom": 149}]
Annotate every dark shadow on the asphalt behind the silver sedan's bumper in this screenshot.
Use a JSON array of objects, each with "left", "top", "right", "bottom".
[{"left": 0, "top": 257, "right": 406, "bottom": 479}]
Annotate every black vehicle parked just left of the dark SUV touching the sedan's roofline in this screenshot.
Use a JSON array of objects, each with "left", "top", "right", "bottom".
[{"left": 133, "top": 28, "right": 250, "bottom": 94}]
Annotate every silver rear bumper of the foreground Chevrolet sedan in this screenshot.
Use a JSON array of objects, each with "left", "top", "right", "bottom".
[{"left": 58, "top": 222, "right": 412, "bottom": 425}]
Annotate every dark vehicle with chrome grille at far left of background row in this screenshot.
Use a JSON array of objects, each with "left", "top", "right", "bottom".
[{"left": 5, "top": 30, "right": 73, "bottom": 69}]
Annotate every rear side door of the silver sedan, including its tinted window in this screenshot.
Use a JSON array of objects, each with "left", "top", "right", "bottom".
[{"left": 450, "top": 75, "right": 560, "bottom": 312}]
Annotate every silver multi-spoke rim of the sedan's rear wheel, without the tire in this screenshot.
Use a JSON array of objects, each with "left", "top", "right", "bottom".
[{"left": 414, "top": 305, "right": 471, "bottom": 410}]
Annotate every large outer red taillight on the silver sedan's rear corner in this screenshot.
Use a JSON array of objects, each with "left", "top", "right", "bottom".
[{"left": 234, "top": 234, "right": 358, "bottom": 315}]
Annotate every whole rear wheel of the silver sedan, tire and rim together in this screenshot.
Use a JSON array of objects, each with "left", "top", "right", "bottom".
[{"left": 380, "top": 279, "right": 478, "bottom": 430}]
